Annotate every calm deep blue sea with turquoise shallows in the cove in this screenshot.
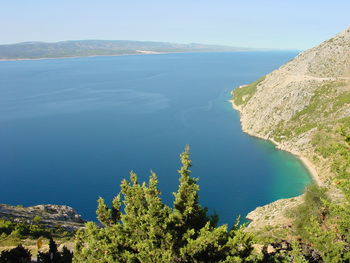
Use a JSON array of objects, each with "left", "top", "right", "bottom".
[{"left": 0, "top": 52, "right": 310, "bottom": 223}]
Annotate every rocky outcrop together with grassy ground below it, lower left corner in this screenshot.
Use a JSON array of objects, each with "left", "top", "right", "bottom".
[{"left": 0, "top": 204, "right": 85, "bottom": 262}]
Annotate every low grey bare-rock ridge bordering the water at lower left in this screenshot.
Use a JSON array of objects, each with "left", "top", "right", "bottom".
[{"left": 0, "top": 204, "right": 84, "bottom": 230}]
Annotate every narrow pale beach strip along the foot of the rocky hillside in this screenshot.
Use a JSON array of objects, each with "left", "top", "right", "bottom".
[{"left": 229, "top": 98, "right": 323, "bottom": 186}]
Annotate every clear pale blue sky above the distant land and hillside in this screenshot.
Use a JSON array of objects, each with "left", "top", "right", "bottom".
[{"left": 0, "top": 0, "right": 350, "bottom": 49}]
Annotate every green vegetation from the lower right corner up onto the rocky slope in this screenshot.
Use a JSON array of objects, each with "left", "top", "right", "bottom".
[{"left": 254, "top": 81, "right": 350, "bottom": 263}]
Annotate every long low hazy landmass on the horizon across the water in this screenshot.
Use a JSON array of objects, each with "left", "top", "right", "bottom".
[{"left": 0, "top": 40, "right": 253, "bottom": 59}]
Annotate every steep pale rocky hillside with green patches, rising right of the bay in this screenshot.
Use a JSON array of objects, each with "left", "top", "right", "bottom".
[{"left": 232, "top": 28, "right": 350, "bottom": 229}]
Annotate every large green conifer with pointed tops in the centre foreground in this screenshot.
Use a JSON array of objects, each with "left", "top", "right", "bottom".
[{"left": 73, "top": 147, "right": 257, "bottom": 263}]
